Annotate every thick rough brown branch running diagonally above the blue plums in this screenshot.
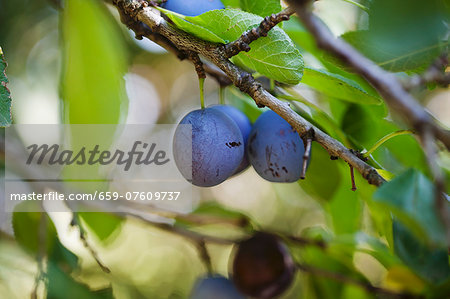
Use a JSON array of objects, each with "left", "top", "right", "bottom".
[{"left": 113, "top": 0, "right": 385, "bottom": 186}]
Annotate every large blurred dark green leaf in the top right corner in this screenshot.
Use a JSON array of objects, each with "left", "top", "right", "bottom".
[{"left": 343, "top": 0, "right": 450, "bottom": 72}]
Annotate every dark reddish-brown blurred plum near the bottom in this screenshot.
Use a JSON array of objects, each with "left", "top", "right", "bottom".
[{"left": 233, "top": 232, "right": 295, "bottom": 298}]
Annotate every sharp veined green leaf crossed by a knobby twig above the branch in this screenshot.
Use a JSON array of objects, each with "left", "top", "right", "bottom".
[{"left": 186, "top": 9, "right": 303, "bottom": 84}]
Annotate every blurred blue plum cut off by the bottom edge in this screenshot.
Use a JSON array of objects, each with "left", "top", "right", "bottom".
[{"left": 190, "top": 275, "right": 245, "bottom": 299}]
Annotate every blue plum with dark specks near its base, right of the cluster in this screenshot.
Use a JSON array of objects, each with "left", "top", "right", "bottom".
[{"left": 247, "top": 110, "right": 305, "bottom": 182}]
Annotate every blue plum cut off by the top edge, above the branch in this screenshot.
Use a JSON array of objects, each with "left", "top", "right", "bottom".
[{"left": 161, "top": 0, "right": 225, "bottom": 17}]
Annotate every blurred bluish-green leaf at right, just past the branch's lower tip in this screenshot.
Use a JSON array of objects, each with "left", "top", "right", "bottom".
[{"left": 374, "top": 169, "right": 445, "bottom": 244}]
